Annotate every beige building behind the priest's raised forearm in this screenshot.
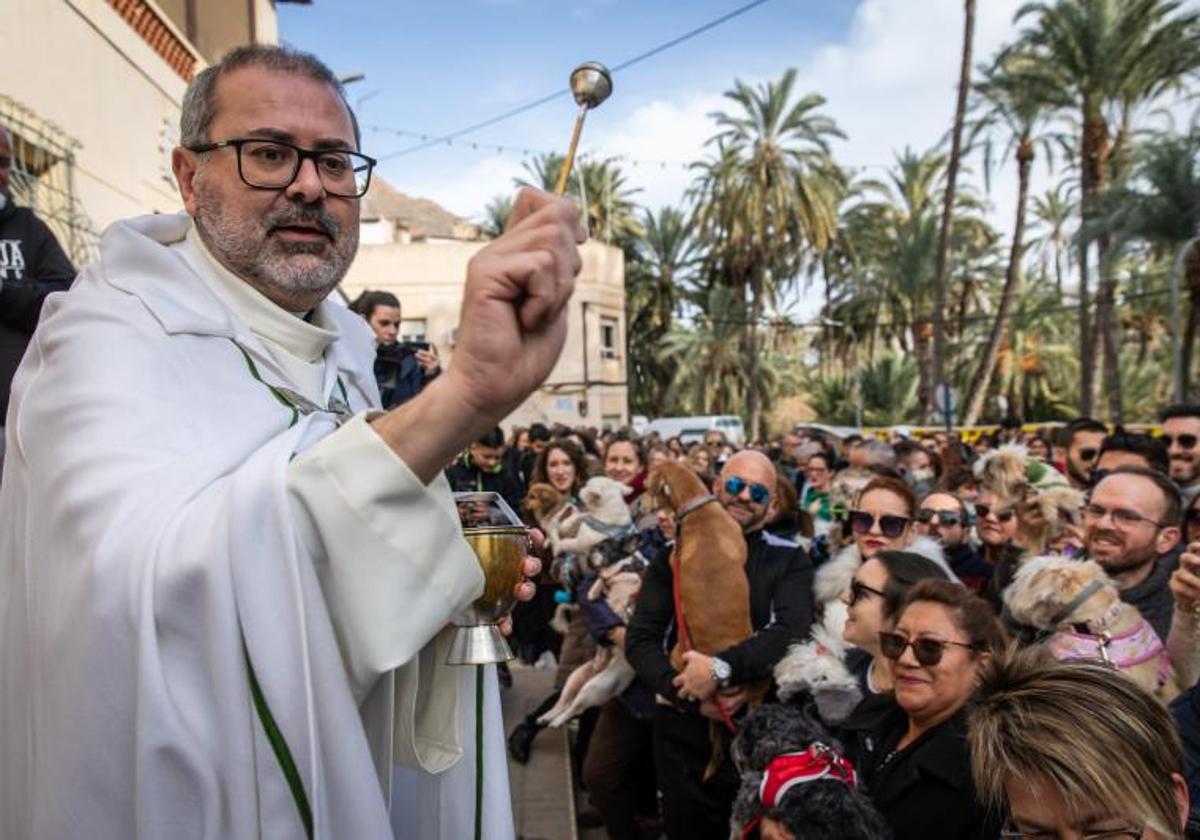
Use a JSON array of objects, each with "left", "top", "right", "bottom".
[{"left": 342, "top": 241, "right": 629, "bottom": 428}]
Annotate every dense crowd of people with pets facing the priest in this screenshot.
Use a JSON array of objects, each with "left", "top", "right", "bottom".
[{"left": 448, "top": 406, "right": 1200, "bottom": 839}]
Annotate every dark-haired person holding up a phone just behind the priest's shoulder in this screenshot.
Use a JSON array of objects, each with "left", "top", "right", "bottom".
[{"left": 350, "top": 292, "right": 442, "bottom": 409}]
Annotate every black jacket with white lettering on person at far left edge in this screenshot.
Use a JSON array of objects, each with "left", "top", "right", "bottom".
[{"left": 0, "top": 203, "right": 76, "bottom": 426}]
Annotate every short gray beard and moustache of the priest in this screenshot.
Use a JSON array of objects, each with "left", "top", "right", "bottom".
[{"left": 194, "top": 194, "right": 359, "bottom": 311}]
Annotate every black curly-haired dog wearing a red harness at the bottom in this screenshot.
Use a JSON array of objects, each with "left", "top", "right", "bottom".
[{"left": 731, "top": 703, "right": 892, "bottom": 840}]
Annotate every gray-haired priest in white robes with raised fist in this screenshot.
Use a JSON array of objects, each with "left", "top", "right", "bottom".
[{"left": 0, "top": 46, "right": 584, "bottom": 840}]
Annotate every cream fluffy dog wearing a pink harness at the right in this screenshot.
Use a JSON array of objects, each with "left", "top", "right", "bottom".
[{"left": 1004, "top": 556, "right": 1180, "bottom": 702}]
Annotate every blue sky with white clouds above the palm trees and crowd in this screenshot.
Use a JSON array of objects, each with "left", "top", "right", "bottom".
[{"left": 278, "top": 0, "right": 1200, "bottom": 314}]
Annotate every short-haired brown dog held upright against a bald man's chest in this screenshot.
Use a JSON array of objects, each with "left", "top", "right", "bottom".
[{"left": 646, "top": 461, "right": 754, "bottom": 671}]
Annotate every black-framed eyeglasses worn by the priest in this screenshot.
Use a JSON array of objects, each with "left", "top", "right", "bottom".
[{"left": 188, "top": 138, "right": 376, "bottom": 198}]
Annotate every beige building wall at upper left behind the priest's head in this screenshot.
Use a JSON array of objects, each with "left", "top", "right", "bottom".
[{"left": 0, "top": 0, "right": 276, "bottom": 242}]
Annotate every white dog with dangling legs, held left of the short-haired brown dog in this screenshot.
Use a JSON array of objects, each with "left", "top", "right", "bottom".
[{"left": 538, "top": 476, "right": 642, "bottom": 726}]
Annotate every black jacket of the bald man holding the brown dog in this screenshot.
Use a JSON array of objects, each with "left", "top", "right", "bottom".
[{"left": 625, "top": 530, "right": 812, "bottom": 707}]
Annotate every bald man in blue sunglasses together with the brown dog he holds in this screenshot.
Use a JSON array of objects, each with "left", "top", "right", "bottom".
[{"left": 625, "top": 451, "right": 812, "bottom": 838}]
